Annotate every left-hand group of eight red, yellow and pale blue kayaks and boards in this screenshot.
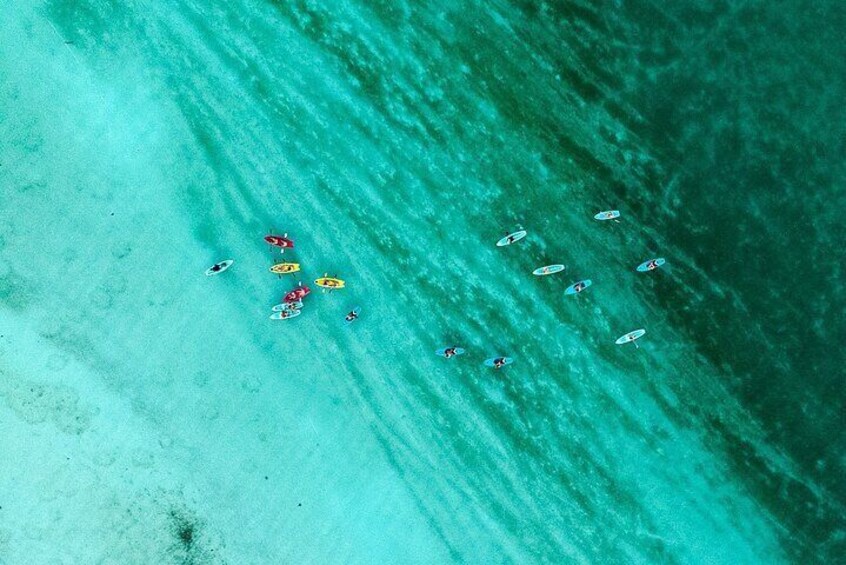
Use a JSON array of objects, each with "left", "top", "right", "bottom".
[{"left": 206, "top": 233, "right": 361, "bottom": 324}]
